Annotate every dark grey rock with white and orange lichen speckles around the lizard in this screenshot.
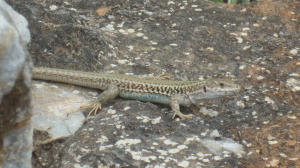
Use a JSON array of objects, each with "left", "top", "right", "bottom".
[{"left": 8, "top": 0, "right": 300, "bottom": 167}]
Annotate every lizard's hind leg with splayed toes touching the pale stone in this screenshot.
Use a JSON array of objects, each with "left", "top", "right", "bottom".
[{"left": 84, "top": 84, "right": 120, "bottom": 121}]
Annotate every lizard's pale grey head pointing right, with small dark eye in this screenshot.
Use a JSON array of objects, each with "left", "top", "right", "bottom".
[{"left": 187, "top": 79, "right": 241, "bottom": 104}]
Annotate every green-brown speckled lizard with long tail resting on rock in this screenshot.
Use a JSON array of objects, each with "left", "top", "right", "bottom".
[{"left": 32, "top": 67, "right": 241, "bottom": 120}]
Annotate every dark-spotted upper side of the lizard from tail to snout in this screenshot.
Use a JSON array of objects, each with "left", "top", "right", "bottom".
[{"left": 33, "top": 68, "right": 236, "bottom": 96}]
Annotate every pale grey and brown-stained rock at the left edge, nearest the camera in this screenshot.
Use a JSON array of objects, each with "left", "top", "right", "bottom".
[{"left": 0, "top": 0, "right": 33, "bottom": 168}]
